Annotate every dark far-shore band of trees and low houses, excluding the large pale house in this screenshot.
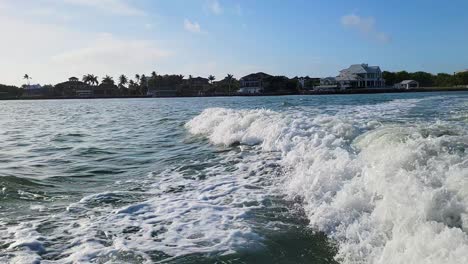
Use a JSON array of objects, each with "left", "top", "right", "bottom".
[{"left": 0, "top": 69, "right": 468, "bottom": 99}]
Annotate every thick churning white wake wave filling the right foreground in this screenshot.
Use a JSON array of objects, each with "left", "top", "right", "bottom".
[{"left": 187, "top": 100, "right": 468, "bottom": 263}]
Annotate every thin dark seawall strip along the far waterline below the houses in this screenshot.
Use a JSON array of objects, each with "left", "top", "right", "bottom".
[{"left": 0, "top": 87, "right": 468, "bottom": 101}]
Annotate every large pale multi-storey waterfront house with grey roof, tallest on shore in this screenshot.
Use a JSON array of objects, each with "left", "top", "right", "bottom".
[{"left": 336, "top": 63, "right": 385, "bottom": 89}]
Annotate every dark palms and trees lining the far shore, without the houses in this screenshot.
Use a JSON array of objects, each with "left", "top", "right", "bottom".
[{"left": 0, "top": 71, "right": 468, "bottom": 98}]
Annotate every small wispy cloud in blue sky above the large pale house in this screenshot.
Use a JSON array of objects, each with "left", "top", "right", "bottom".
[{"left": 341, "top": 14, "right": 391, "bottom": 43}]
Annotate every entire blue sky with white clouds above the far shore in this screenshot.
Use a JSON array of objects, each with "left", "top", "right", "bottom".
[{"left": 0, "top": 0, "right": 468, "bottom": 85}]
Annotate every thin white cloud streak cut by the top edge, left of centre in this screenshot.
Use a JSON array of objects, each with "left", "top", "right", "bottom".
[{"left": 64, "top": 0, "right": 145, "bottom": 16}]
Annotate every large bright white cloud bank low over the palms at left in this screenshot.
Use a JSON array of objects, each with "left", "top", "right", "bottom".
[{"left": 0, "top": 10, "right": 170, "bottom": 85}]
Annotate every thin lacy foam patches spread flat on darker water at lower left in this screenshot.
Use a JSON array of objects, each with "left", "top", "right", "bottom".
[{"left": 0, "top": 150, "right": 280, "bottom": 263}]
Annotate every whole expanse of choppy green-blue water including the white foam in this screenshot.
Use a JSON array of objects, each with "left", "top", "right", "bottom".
[{"left": 0, "top": 92, "right": 468, "bottom": 263}]
